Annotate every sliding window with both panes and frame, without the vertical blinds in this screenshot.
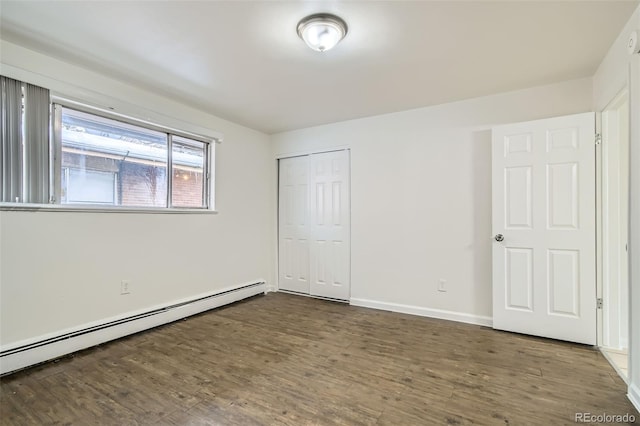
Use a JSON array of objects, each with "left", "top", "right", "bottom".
[{"left": 54, "top": 104, "right": 210, "bottom": 209}]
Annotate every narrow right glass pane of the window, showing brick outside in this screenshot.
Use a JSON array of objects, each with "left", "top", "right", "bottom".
[{"left": 171, "top": 136, "right": 206, "bottom": 207}]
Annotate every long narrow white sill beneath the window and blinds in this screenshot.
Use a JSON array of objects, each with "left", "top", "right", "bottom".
[{"left": 0, "top": 203, "right": 218, "bottom": 214}]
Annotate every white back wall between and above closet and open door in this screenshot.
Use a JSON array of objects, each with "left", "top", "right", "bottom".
[{"left": 272, "top": 79, "right": 592, "bottom": 323}]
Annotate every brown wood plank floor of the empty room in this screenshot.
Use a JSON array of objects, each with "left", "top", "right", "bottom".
[{"left": 0, "top": 293, "right": 640, "bottom": 426}]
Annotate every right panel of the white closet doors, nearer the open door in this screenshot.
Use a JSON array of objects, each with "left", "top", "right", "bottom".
[{"left": 309, "top": 151, "right": 350, "bottom": 300}]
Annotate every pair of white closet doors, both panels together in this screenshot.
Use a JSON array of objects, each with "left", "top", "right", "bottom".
[{"left": 279, "top": 150, "right": 351, "bottom": 300}]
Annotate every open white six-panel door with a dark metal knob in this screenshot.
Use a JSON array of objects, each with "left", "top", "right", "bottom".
[{"left": 492, "top": 113, "right": 596, "bottom": 344}]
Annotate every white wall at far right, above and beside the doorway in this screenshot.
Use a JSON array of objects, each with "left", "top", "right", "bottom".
[{"left": 593, "top": 3, "right": 640, "bottom": 410}]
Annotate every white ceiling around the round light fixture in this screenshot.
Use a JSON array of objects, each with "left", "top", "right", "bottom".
[{"left": 0, "top": 0, "right": 638, "bottom": 133}]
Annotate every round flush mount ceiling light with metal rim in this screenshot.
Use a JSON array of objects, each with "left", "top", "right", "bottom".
[{"left": 298, "top": 13, "right": 347, "bottom": 52}]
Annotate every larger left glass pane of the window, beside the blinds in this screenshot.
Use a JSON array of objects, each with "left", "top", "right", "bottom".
[{"left": 61, "top": 108, "right": 168, "bottom": 207}]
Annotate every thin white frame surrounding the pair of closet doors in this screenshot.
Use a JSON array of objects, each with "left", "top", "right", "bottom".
[{"left": 270, "top": 145, "right": 353, "bottom": 304}]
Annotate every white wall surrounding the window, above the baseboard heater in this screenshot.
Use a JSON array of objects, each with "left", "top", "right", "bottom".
[{"left": 0, "top": 41, "right": 275, "bottom": 347}]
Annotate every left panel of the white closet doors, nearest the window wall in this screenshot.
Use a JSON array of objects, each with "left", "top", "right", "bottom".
[{"left": 278, "top": 156, "right": 309, "bottom": 294}]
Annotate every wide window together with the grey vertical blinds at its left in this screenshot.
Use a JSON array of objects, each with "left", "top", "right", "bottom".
[{"left": 0, "top": 77, "right": 215, "bottom": 210}]
